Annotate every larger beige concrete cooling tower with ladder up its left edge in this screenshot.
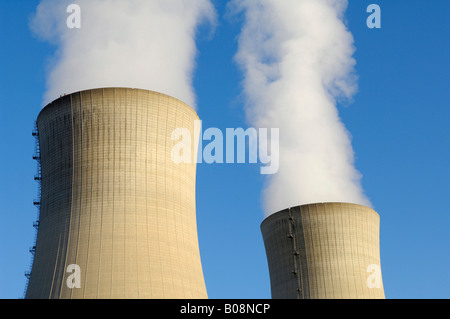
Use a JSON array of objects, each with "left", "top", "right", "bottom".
[{"left": 25, "top": 88, "right": 207, "bottom": 299}]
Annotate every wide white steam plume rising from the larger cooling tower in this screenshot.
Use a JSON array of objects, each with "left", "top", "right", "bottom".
[{"left": 30, "top": 0, "right": 216, "bottom": 108}]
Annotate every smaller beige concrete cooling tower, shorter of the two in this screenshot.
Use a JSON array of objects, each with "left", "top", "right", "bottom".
[{"left": 261, "top": 203, "right": 385, "bottom": 299}]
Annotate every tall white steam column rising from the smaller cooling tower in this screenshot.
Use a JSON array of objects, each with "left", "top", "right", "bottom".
[{"left": 232, "top": 0, "right": 370, "bottom": 215}]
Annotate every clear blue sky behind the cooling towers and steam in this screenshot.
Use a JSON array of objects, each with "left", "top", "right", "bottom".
[{"left": 0, "top": 0, "right": 450, "bottom": 298}]
